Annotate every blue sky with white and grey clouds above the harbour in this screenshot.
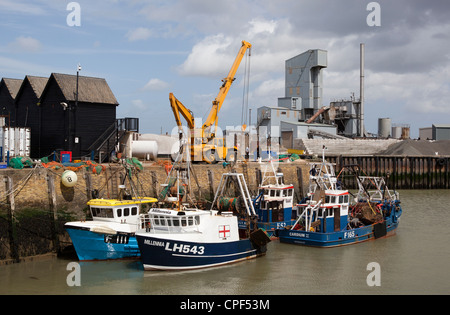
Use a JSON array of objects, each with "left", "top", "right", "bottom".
[{"left": 0, "top": 0, "right": 450, "bottom": 137}]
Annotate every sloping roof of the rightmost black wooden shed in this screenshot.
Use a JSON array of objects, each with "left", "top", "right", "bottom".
[{"left": 42, "top": 73, "right": 119, "bottom": 105}]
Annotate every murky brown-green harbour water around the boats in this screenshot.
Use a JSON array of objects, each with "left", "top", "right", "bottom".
[{"left": 0, "top": 190, "right": 450, "bottom": 298}]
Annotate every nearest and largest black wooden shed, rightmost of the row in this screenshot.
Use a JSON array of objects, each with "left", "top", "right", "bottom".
[{"left": 37, "top": 73, "right": 119, "bottom": 159}]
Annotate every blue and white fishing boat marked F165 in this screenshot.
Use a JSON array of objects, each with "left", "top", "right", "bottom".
[{"left": 277, "top": 149, "right": 402, "bottom": 247}]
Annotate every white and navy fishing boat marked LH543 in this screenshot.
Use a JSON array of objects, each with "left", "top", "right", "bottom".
[{"left": 136, "top": 173, "right": 270, "bottom": 270}]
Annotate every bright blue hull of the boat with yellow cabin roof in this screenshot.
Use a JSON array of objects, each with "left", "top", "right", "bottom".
[{"left": 66, "top": 226, "right": 140, "bottom": 261}]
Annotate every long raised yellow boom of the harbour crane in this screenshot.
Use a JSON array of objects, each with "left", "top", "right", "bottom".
[{"left": 202, "top": 40, "right": 252, "bottom": 130}]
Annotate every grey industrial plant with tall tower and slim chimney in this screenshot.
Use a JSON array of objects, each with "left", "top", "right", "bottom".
[{"left": 253, "top": 44, "right": 426, "bottom": 155}]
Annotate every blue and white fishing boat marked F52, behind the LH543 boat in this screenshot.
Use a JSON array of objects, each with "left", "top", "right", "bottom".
[{"left": 239, "top": 161, "right": 297, "bottom": 238}]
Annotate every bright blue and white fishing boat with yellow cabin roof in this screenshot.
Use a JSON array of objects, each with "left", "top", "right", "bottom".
[{"left": 65, "top": 197, "right": 157, "bottom": 261}]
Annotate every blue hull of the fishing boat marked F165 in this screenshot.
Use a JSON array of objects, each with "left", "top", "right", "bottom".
[{"left": 277, "top": 220, "right": 399, "bottom": 247}]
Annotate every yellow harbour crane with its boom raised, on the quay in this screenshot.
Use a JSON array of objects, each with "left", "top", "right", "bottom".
[{"left": 169, "top": 41, "right": 252, "bottom": 163}]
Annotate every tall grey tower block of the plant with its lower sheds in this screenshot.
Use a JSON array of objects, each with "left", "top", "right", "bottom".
[{"left": 257, "top": 49, "right": 337, "bottom": 149}]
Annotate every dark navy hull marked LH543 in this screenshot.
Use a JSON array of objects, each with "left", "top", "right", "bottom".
[{"left": 136, "top": 234, "right": 265, "bottom": 270}]
